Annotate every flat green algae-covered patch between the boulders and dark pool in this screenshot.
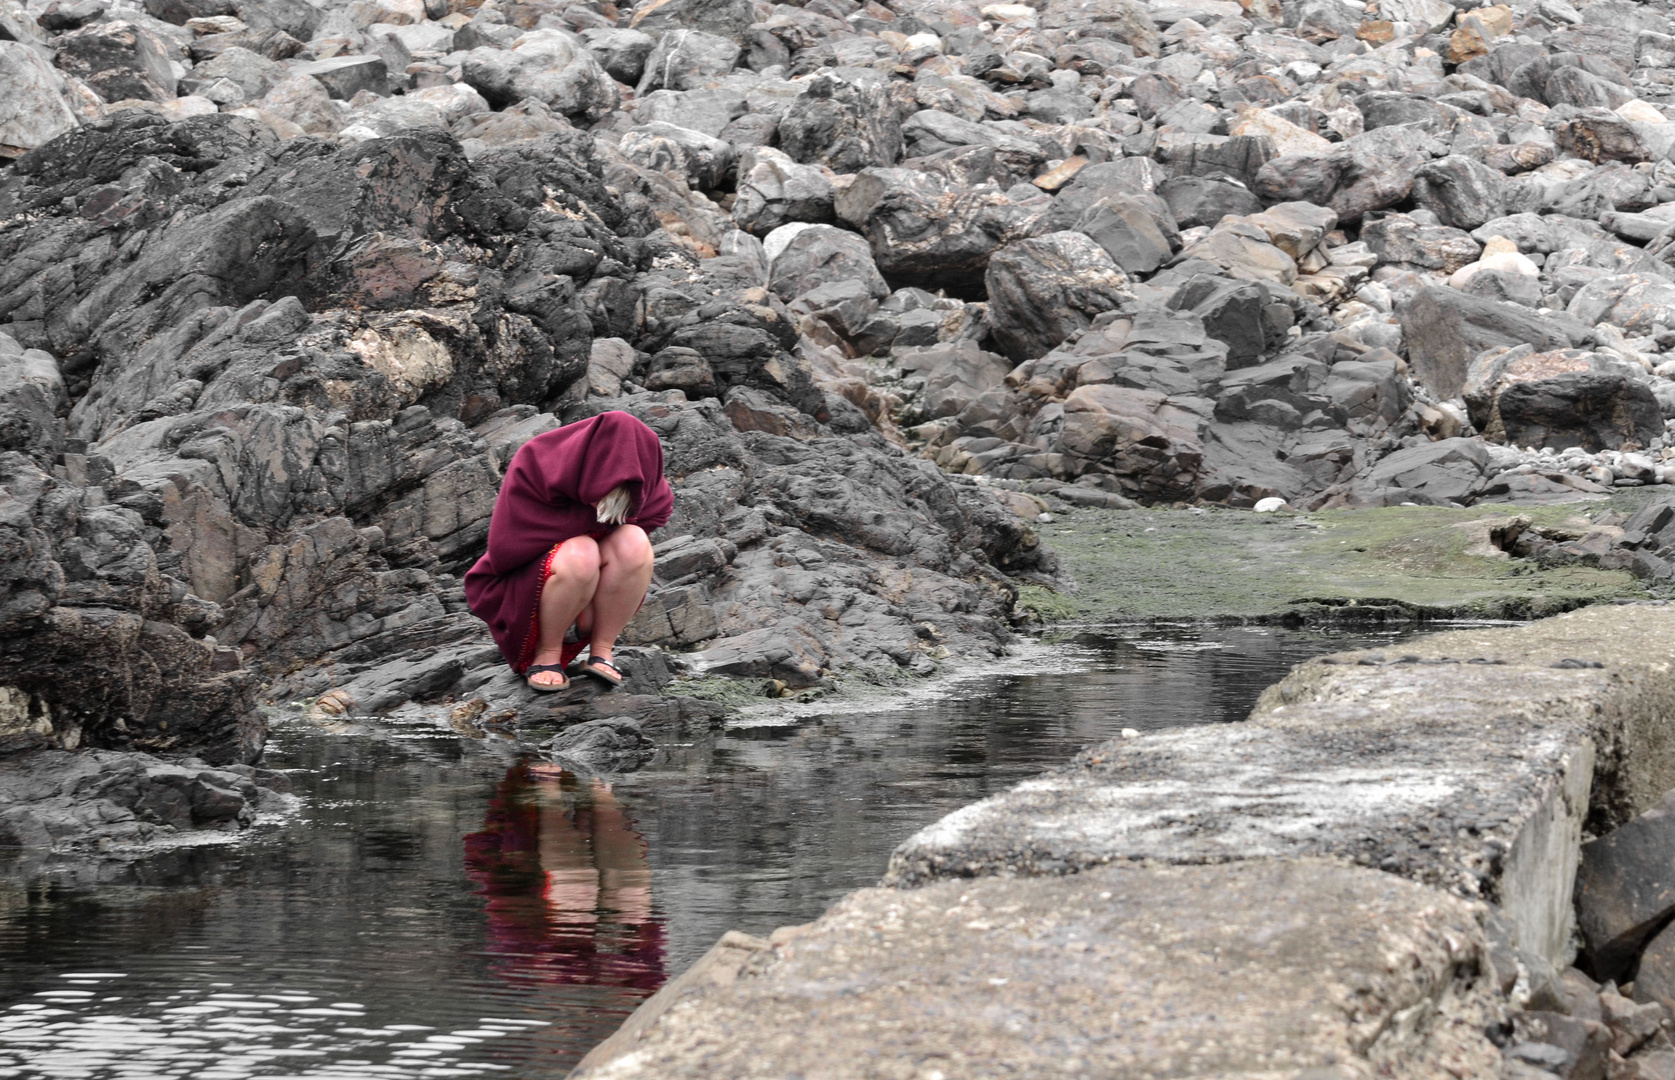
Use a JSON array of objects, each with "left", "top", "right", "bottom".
[{"left": 1020, "top": 501, "right": 1647, "bottom": 621}]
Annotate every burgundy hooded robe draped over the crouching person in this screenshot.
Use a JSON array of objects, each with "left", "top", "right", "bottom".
[{"left": 464, "top": 412, "right": 675, "bottom": 675}]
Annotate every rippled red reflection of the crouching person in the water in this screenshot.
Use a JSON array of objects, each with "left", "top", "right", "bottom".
[{"left": 466, "top": 762, "right": 663, "bottom": 993}]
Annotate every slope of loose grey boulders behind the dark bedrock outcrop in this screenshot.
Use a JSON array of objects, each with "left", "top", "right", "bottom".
[{"left": 0, "top": 0, "right": 1675, "bottom": 535}]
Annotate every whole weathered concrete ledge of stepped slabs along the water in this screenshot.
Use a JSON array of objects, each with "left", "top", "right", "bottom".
[{"left": 576, "top": 606, "right": 1675, "bottom": 1080}]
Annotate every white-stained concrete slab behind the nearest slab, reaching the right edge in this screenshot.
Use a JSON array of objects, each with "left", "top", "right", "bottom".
[{"left": 886, "top": 604, "right": 1675, "bottom": 961}]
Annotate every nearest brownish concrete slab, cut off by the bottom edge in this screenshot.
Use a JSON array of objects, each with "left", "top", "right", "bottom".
[{"left": 573, "top": 861, "right": 1499, "bottom": 1080}]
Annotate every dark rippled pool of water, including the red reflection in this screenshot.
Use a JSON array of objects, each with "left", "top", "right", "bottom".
[{"left": 0, "top": 628, "right": 1397, "bottom": 1080}]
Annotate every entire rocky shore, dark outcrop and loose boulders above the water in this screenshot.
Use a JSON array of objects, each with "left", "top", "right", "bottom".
[{"left": 0, "top": 0, "right": 1675, "bottom": 847}]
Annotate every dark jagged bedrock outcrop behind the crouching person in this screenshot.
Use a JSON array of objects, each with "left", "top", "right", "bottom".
[{"left": 0, "top": 61, "right": 1052, "bottom": 800}]
